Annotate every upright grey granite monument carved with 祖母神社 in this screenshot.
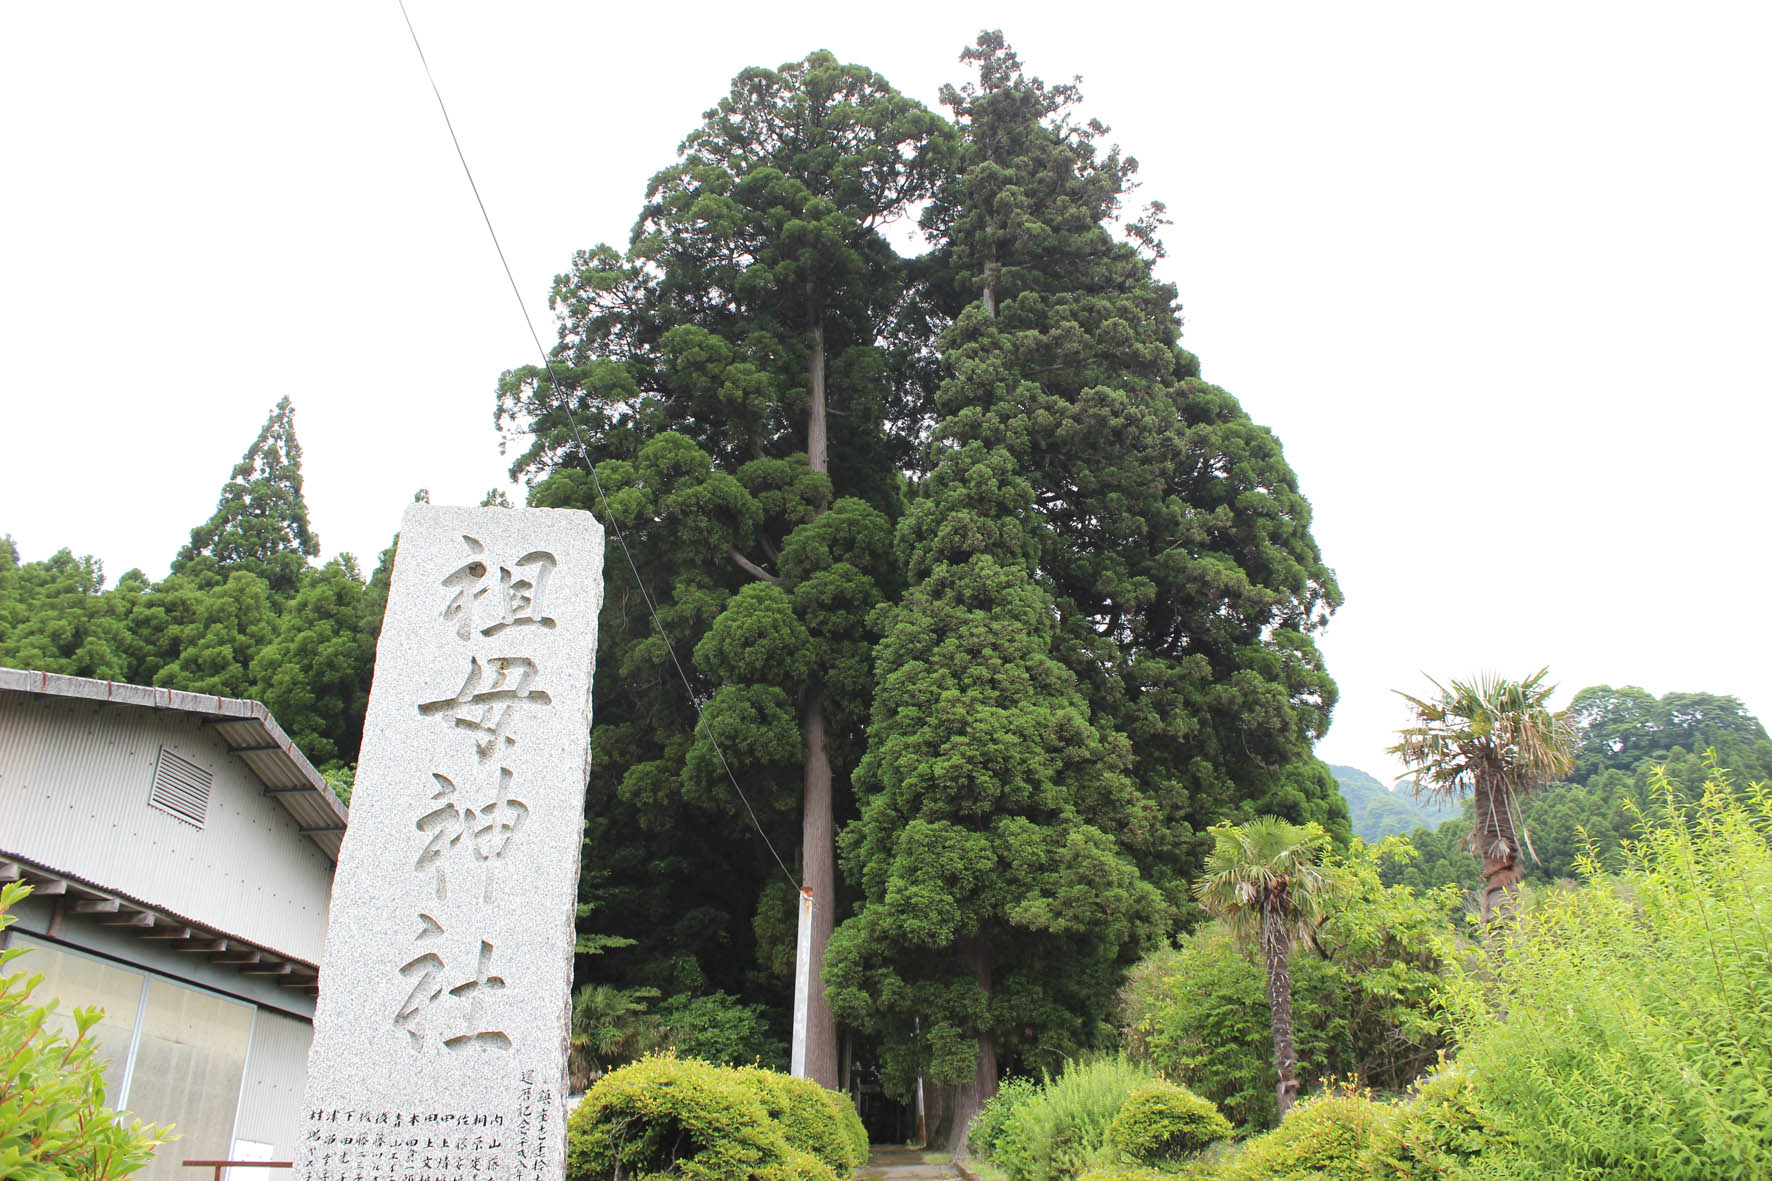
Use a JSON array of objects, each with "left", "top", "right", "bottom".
[{"left": 296, "top": 504, "right": 602, "bottom": 1181}]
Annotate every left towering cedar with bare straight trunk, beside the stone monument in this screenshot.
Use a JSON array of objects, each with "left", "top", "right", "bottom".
[{"left": 500, "top": 51, "right": 952, "bottom": 1085}]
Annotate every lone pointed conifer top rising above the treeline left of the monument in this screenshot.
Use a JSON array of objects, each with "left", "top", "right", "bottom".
[{"left": 172, "top": 397, "right": 321, "bottom": 599}]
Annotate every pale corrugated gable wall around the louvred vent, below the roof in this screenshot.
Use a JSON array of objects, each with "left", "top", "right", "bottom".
[{"left": 0, "top": 693, "right": 333, "bottom": 963}]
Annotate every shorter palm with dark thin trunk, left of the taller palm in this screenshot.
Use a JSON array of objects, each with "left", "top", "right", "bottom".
[{"left": 1194, "top": 816, "right": 1338, "bottom": 1119}]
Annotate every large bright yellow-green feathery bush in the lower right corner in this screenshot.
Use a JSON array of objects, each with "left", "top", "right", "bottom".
[{"left": 1455, "top": 766, "right": 1772, "bottom": 1179}]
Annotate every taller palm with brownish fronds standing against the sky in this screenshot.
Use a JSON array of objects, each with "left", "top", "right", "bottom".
[{"left": 1389, "top": 669, "right": 1575, "bottom": 922}]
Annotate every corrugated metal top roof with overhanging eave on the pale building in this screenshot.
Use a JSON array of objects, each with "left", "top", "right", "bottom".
[{"left": 0, "top": 669, "right": 349, "bottom": 865}]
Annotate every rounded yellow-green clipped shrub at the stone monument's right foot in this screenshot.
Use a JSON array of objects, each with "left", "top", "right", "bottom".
[{"left": 567, "top": 1055, "right": 847, "bottom": 1181}]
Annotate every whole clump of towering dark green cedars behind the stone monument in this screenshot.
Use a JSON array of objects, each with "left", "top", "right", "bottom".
[{"left": 498, "top": 34, "right": 1347, "bottom": 1106}]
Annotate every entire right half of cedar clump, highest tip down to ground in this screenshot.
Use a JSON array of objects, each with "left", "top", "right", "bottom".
[{"left": 831, "top": 32, "right": 1347, "bottom": 1144}]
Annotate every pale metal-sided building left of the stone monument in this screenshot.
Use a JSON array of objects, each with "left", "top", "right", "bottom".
[{"left": 0, "top": 669, "right": 347, "bottom": 1181}]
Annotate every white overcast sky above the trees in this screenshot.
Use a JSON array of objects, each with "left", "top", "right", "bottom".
[{"left": 0, "top": 0, "right": 1772, "bottom": 778}]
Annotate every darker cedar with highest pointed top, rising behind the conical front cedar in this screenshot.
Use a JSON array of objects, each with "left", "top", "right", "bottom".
[{"left": 925, "top": 32, "right": 1348, "bottom": 911}]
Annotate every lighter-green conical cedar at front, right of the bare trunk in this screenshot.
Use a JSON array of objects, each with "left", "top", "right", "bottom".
[{"left": 829, "top": 439, "right": 1164, "bottom": 1147}]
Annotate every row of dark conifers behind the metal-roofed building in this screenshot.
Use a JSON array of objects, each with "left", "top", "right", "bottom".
[{"left": 0, "top": 397, "right": 380, "bottom": 768}]
